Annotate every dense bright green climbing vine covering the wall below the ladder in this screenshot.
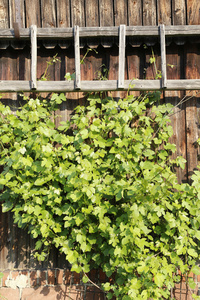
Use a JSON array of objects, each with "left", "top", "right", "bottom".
[{"left": 0, "top": 94, "right": 200, "bottom": 300}]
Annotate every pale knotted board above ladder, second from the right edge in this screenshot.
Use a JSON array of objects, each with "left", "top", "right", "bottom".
[{"left": 172, "top": 0, "right": 186, "bottom": 25}]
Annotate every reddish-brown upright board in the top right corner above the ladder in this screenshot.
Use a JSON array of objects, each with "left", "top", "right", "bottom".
[{"left": 187, "top": 0, "right": 200, "bottom": 25}]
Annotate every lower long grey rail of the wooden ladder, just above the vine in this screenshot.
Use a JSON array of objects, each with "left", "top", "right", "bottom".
[{"left": 0, "top": 79, "right": 200, "bottom": 92}]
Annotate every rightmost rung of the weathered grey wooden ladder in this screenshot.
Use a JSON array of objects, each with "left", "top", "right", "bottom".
[{"left": 160, "top": 24, "right": 167, "bottom": 89}]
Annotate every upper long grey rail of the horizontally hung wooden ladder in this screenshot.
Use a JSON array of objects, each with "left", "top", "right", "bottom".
[{"left": 0, "top": 25, "right": 200, "bottom": 39}]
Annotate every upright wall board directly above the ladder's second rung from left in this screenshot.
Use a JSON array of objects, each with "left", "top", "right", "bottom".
[{"left": 71, "top": 0, "right": 86, "bottom": 27}]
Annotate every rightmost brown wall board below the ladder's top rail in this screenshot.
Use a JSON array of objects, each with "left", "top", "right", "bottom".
[{"left": 185, "top": 44, "right": 200, "bottom": 178}]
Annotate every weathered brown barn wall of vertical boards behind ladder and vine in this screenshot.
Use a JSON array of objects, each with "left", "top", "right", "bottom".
[{"left": 0, "top": 0, "right": 200, "bottom": 270}]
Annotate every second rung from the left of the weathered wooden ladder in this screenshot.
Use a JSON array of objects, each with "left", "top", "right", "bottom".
[{"left": 74, "top": 25, "right": 81, "bottom": 89}]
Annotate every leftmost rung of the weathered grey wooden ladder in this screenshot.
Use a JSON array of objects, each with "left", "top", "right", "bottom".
[{"left": 30, "top": 25, "right": 37, "bottom": 89}]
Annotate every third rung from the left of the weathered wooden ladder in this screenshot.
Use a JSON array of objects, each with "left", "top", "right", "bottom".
[{"left": 118, "top": 25, "right": 126, "bottom": 89}]
